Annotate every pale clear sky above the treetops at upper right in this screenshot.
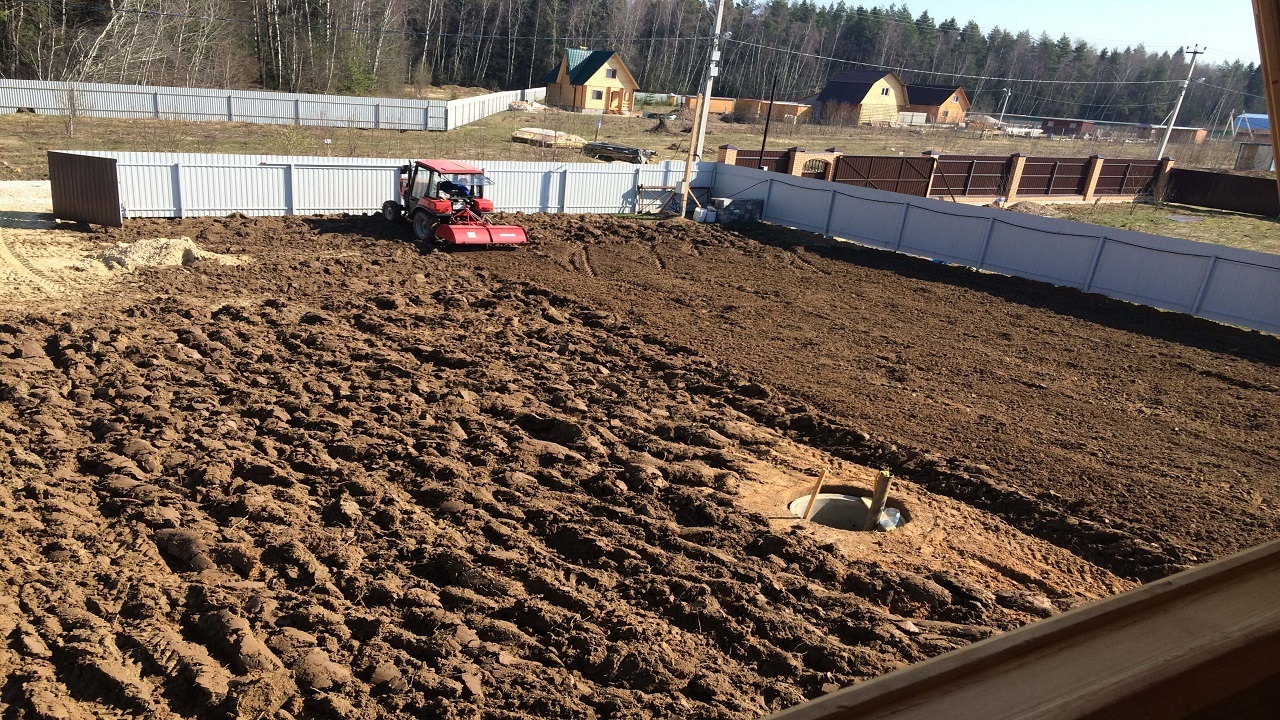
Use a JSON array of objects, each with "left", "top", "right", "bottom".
[{"left": 885, "top": 0, "right": 1258, "bottom": 65}]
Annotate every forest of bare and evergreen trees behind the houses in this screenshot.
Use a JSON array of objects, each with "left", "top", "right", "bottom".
[{"left": 0, "top": 0, "right": 1265, "bottom": 127}]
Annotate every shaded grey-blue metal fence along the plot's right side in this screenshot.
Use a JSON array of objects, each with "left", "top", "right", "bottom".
[{"left": 714, "top": 165, "right": 1280, "bottom": 333}]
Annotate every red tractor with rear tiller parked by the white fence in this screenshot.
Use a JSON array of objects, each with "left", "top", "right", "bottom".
[{"left": 383, "top": 160, "right": 529, "bottom": 245}]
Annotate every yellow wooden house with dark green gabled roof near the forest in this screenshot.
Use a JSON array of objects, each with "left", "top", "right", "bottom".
[{"left": 544, "top": 47, "right": 639, "bottom": 115}]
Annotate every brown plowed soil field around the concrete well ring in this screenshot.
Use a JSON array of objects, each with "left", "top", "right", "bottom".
[{"left": 0, "top": 197, "right": 1280, "bottom": 720}]
